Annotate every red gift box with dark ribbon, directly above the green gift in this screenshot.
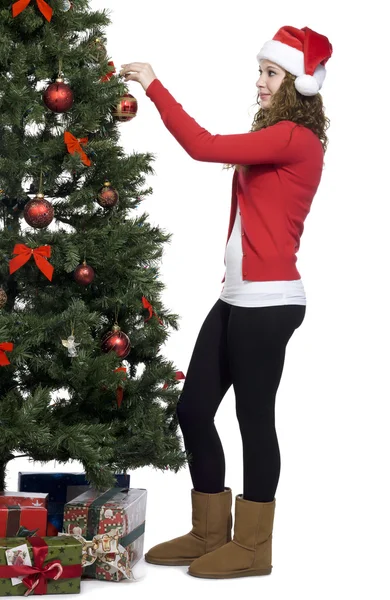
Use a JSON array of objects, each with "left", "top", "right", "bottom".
[{"left": 0, "top": 504, "right": 47, "bottom": 537}]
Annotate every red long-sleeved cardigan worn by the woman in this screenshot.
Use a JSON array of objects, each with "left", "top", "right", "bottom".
[{"left": 146, "top": 79, "right": 324, "bottom": 283}]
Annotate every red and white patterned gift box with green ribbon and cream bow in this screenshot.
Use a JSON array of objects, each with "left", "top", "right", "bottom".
[{"left": 64, "top": 488, "right": 147, "bottom": 581}]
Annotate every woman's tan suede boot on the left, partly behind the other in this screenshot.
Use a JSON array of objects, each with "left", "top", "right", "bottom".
[{"left": 145, "top": 488, "right": 232, "bottom": 565}]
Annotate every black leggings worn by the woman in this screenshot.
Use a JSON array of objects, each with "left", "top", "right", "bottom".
[{"left": 177, "top": 299, "right": 306, "bottom": 502}]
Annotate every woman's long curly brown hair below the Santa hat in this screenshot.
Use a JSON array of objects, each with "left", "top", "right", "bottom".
[{"left": 223, "top": 71, "right": 330, "bottom": 175}]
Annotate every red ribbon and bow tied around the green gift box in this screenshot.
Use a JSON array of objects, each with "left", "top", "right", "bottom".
[{"left": 0, "top": 537, "right": 82, "bottom": 596}]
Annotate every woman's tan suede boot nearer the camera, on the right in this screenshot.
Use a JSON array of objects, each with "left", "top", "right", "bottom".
[{"left": 188, "top": 494, "right": 275, "bottom": 579}]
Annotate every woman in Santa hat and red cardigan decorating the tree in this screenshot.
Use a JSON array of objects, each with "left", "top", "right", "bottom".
[{"left": 121, "top": 26, "right": 332, "bottom": 578}]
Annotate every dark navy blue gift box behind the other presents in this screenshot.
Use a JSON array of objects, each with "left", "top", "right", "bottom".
[{"left": 18, "top": 472, "right": 130, "bottom": 536}]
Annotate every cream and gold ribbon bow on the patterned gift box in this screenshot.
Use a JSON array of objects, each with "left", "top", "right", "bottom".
[{"left": 58, "top": 529, "right": 132, "bottom": 579}]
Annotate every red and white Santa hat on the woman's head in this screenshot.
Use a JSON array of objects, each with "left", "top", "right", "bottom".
[{"left": 257, "top": 25, "right": 333, "bottom": 96}]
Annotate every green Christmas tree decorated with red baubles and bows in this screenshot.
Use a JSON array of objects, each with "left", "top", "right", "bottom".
[{"left": 0, "top": 0, "right": 187, "bottom": 489}]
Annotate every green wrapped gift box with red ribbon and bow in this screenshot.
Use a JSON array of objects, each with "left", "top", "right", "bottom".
[{"left": 0, "top": 536, "right": 82, "bottom": 596}]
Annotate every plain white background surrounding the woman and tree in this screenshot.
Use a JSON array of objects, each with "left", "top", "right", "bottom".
[{"left": 3, "top": 0, "right": 390, "bottom": 600}]
